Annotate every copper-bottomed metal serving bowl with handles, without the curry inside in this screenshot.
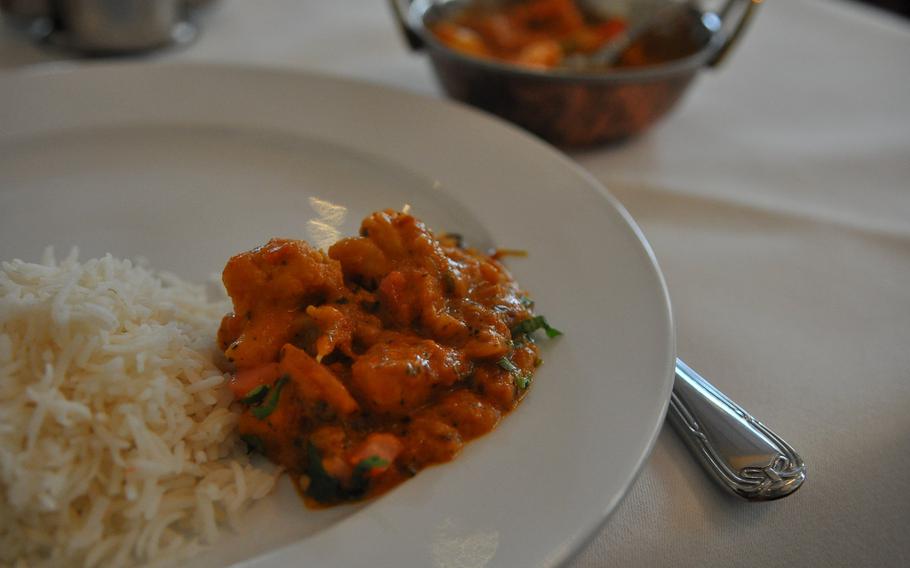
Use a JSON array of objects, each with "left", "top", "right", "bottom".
[{"left": 390, "top": 0, "right": 761, "bottom": 146}]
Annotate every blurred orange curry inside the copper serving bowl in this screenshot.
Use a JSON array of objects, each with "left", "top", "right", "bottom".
[{"left": 430, "top": 0, "right": 626, "bottom": 69}]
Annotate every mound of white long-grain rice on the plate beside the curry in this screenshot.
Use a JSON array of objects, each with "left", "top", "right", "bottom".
[{"left": 0, "top": 248, "right": 277, "bottom": 567}]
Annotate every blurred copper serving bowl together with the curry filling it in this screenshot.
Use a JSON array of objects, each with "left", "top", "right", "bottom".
[{"left": 390, "top": 0, "right": 761, "bottom": 147}]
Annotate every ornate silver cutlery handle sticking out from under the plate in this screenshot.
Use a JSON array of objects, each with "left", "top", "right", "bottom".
[{"left": 667, "top": 359, "right": 806, "bottom": 501}]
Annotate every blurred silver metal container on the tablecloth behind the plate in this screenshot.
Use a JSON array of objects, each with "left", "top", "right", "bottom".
[{"left": 0, "top": 0, "right": 217, "bottom": 55}]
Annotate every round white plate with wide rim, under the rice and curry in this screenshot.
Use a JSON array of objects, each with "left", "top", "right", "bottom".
[{"left": 0, "top": 65, "right": 675, "bottom": 568}]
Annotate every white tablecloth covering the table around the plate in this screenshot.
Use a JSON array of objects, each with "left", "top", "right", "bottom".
[{"left": 0, "top": 0, "right": 910, "bottom": 568}]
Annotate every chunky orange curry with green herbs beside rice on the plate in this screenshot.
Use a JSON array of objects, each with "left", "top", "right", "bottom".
[{"left": 218, "top": 211, "right": 559, "bottom": 506}]
